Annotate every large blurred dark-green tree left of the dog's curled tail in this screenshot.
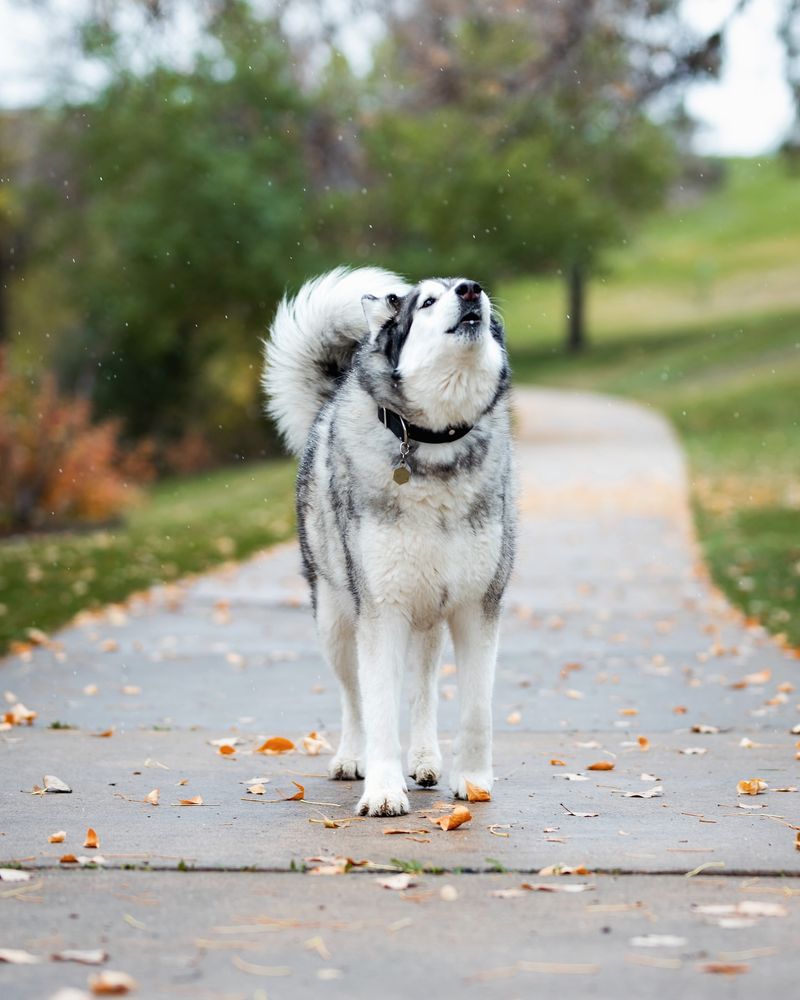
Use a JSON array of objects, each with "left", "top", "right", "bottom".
[{"left": 39, "top": 2, "right": 318, "bottom": 453}]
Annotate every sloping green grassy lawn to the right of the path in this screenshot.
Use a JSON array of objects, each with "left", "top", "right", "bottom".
[{"left": 499, "top": 153, "right": 800, "bottom": 646}]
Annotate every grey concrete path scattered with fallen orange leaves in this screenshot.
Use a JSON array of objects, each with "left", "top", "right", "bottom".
[{"left": 0, "top": 390, "right": 800, "bottom": 998}]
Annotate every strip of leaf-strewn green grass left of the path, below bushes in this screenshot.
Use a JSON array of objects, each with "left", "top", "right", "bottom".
[{"left": 0, "top": 461, "right": 294, "bottom": 652}]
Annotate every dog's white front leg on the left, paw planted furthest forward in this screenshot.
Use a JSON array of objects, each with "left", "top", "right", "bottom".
[{"left": 357, "top": 610, "right": 411, "bottom": 816}]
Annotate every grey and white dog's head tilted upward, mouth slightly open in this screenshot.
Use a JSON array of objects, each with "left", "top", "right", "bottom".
[{"left": 362, "top": 278, "right": 507, "bottom": 430}]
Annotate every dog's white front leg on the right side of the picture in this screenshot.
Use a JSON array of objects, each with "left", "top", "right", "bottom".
[{"left": 450, "top": 605, "right": 499, "bottom": 799}]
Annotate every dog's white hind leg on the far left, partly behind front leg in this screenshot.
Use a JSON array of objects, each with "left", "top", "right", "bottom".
[{"left": 317, "top": 580, "right": 364, "bottom": 781}]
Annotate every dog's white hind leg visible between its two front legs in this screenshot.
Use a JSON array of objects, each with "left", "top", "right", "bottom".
[{"left": 408, "top": 625, "right": 444, "bottom": 786}]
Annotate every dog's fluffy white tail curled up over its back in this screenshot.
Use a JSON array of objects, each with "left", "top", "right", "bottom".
[{"left": 262, "top": 267, "right": 408, "bottom": 455}]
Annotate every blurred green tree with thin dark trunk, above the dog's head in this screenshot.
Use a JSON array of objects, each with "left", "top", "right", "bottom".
[{"left": 346, "top": 0, "right": 720, "bottom": 349}]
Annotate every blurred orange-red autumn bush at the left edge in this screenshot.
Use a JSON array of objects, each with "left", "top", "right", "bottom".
[{"left": 0, "top": 354, "right": 154, "bottom": 534}]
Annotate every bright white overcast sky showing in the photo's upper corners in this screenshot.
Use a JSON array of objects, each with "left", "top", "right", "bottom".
[{"left": 0, "top": 0, "right": 793, "bottom": 156}]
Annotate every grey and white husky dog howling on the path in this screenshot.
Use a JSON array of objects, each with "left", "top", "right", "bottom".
[{"left": 263, "top": 268, "right": 515, "bottom": 816}]
